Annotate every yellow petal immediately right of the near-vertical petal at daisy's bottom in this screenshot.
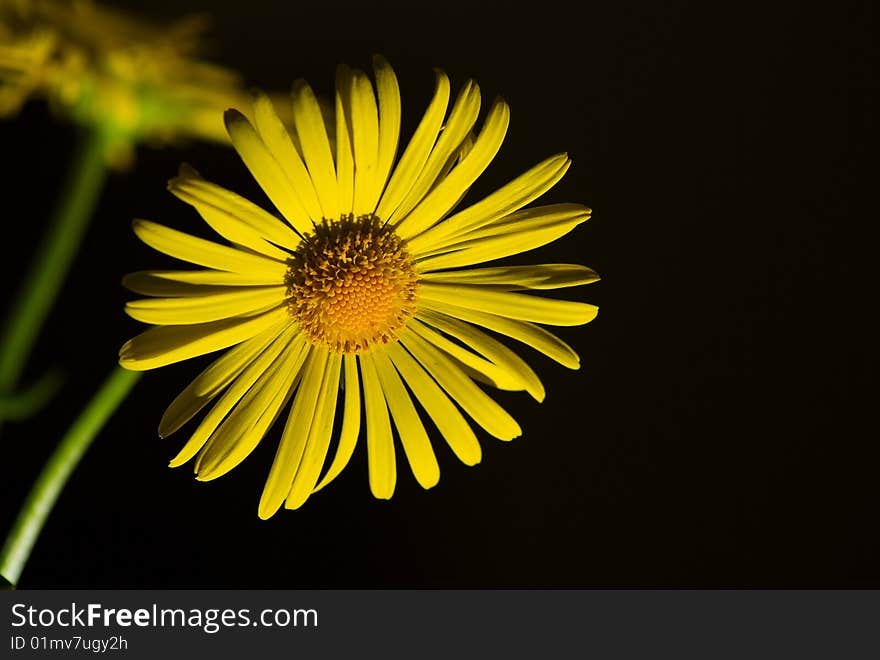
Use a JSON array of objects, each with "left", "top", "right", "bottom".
[{"left": 372, "top": 352, "right": 440, "bottom": 488}]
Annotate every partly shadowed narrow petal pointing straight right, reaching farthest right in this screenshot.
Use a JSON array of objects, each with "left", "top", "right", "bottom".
[{"left": 420, "top": 264, "right": 599, "bottom": 291}]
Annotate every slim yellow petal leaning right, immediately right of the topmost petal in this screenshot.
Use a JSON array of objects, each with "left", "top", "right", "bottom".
[{"left": 376, "top": 69, "right": 449, "bottom": 219}]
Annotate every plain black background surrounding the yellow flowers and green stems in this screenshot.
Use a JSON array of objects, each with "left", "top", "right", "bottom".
[{"left": 0, "top": 0, "right": 880, "bottom": 588}]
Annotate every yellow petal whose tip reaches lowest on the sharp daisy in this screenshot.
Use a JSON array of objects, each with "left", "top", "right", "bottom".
[{"left": 258, "top": 347, "right": 328, "bottom": 520}]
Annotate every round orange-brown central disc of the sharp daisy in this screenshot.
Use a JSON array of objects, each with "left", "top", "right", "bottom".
[{"left": 284, "top": 215, "right": 418, "bottom": 353}]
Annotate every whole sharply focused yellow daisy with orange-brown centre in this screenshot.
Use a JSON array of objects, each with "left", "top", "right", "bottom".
[{"left": 120, "top": 57, "right": 598, "bottom": 518}]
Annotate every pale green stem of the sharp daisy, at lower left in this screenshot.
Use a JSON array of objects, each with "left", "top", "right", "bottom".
[{"left": 0, "top": 367, "right": 141, "bottom": 586}]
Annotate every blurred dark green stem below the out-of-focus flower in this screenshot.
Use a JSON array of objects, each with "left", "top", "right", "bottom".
[{"left": 0, "top": 128, "right": 107, "bottom": 396}]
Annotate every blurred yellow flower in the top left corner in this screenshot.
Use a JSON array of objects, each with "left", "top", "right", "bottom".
[{"left": 0, "top": 0, "right": 249, "bottom": 166}]
